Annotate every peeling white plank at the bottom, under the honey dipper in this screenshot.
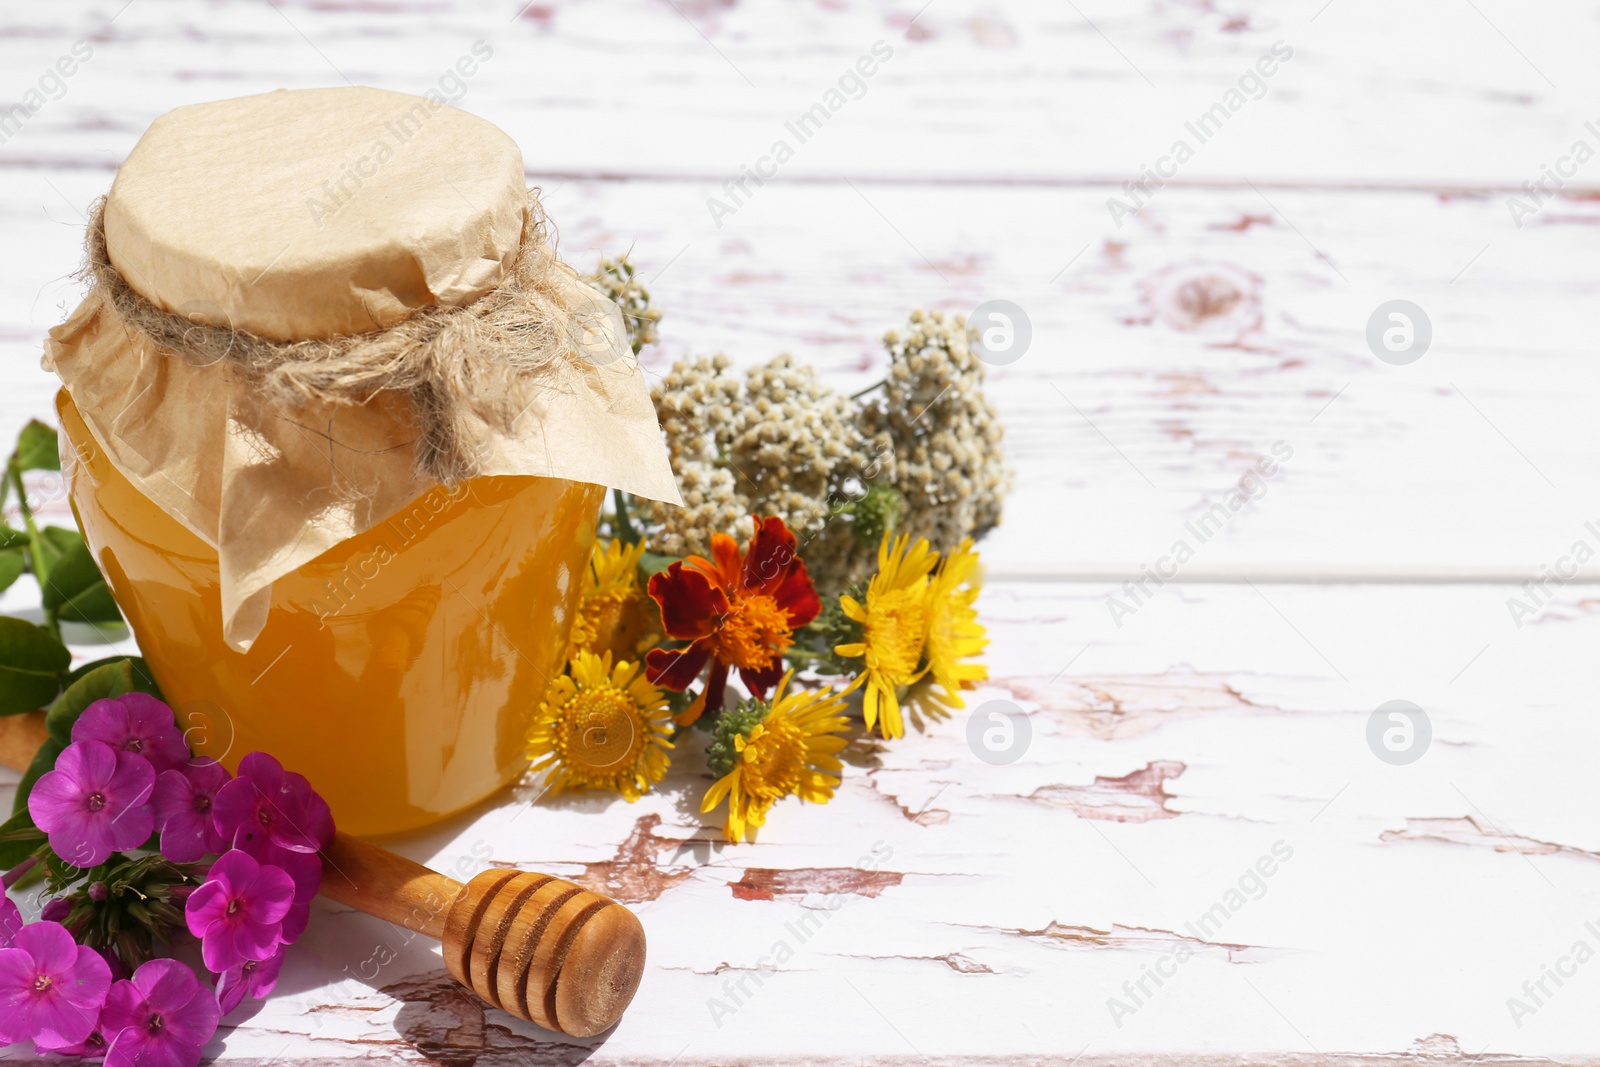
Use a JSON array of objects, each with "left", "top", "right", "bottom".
[{"left": 3, "top": 584, "right": 1600, "bottom": 1064}]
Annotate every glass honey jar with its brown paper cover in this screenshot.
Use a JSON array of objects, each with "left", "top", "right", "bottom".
[{"left": 45, "top": 88, "right": 677, "bottom": 833}]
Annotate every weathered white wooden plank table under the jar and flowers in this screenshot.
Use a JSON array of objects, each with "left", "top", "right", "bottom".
[{"left": 0, "top": 0, "right": 1600, "bottom": 1067}]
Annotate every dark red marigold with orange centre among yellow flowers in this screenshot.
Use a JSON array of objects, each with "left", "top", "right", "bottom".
[{"left": 645, "top": 515, "right": 822, "bottom": 726}]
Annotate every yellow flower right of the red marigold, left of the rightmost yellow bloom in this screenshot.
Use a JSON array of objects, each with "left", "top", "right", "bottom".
[{"left": 834, "top": 534, "right": 939, "bottom": 737}]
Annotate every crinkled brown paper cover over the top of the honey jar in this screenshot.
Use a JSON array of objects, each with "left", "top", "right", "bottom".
[{"left": 43, "top": 88, "right": 682, "bottom": 649}]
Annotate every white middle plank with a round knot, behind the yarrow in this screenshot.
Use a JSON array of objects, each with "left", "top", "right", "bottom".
[{"left": 12, "top": 171, "right": 1600, "bottom": 592}]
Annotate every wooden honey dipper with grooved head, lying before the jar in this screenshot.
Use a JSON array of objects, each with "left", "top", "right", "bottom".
[{"left": 0, "top": 712, "right": 645, "bottom": 1037}]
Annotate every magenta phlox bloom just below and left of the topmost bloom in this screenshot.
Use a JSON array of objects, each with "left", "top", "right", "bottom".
[{"left": 27, "top": 741, "right": 155, "bottom": 867}]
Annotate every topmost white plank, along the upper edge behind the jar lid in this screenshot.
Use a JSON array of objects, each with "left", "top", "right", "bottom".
[{"left": 0, "top": 0, "right": 1600, "bottom": 189}]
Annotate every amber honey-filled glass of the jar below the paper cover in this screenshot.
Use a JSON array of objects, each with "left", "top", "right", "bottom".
[{"left": 56, "top": 390, "right": 605, "bottom": 833}]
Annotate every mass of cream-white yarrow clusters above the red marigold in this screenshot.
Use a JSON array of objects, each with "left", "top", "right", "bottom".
[{"left": 650, "top": 310, "right": 1011, "bottom": 595}]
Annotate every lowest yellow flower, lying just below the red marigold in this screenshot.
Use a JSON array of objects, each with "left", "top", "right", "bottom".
[{"left": 701, "top": 670, "right": 850, "bottom": 841}]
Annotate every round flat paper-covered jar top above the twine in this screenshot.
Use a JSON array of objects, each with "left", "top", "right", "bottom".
[{"left": 106, "top": 86, "right": 528, "bottom": 341}]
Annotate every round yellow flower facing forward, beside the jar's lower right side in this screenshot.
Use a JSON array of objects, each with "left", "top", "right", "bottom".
[{"left": 528, "top": 651, "right": 672, "bottom": 801}]
